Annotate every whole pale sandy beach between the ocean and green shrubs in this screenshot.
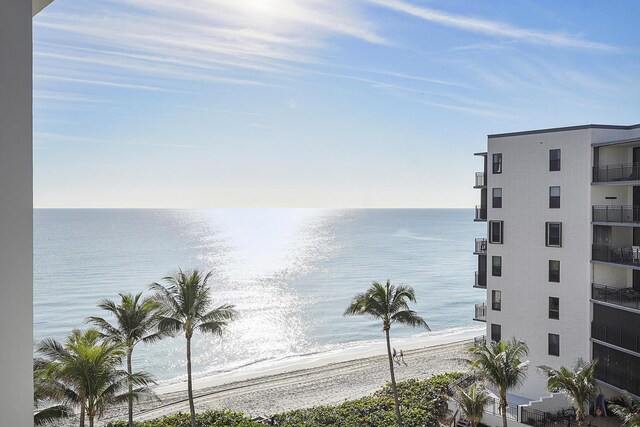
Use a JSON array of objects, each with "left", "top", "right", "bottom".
[{"left": 101, "top": 330, "right": 479, "bottom": 423}]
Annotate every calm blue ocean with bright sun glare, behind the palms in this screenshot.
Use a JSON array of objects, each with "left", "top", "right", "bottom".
[{"left": 34, "top": 209, "right": 486, "bottom": 384}]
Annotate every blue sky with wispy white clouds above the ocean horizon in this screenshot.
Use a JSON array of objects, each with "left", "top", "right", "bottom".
[{"left": 33, "top": 0, "right": 640, "bottom": 208}]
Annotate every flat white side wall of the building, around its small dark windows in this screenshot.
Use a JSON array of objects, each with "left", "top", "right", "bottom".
[{"left": 487, "top": 129, "right": 592, "bottom": 399}]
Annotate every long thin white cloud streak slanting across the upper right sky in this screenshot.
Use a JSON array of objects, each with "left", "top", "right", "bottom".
[{"left": 369, "top": 0, "right": 621, "bottom": 52}]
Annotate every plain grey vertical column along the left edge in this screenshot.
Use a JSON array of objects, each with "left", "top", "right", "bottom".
[{"left": 0, "top": 0, "right": 33, "bottom": 426}]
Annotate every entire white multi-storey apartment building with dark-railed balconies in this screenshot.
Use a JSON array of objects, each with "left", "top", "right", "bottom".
[{"left": 474, "top": 125, "right": 640, "bottom": 399}]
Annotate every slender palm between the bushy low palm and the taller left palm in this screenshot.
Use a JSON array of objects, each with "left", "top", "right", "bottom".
[{"left": 87, "top": 292, "right": 163, "bottom": 427}]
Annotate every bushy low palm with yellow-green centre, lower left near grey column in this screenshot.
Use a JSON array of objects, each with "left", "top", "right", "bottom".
[{"left": 38, "top": 329, "right": 150, "bottom": 427}]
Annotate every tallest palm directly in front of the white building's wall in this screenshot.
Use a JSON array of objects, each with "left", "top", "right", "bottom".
[{"left": 467, "top": 337, "right": 529, "bottom": 427}]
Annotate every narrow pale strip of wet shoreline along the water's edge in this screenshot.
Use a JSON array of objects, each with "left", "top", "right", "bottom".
[{"left": 153, "top": 328, "right": 485, "bottom": 395}]
